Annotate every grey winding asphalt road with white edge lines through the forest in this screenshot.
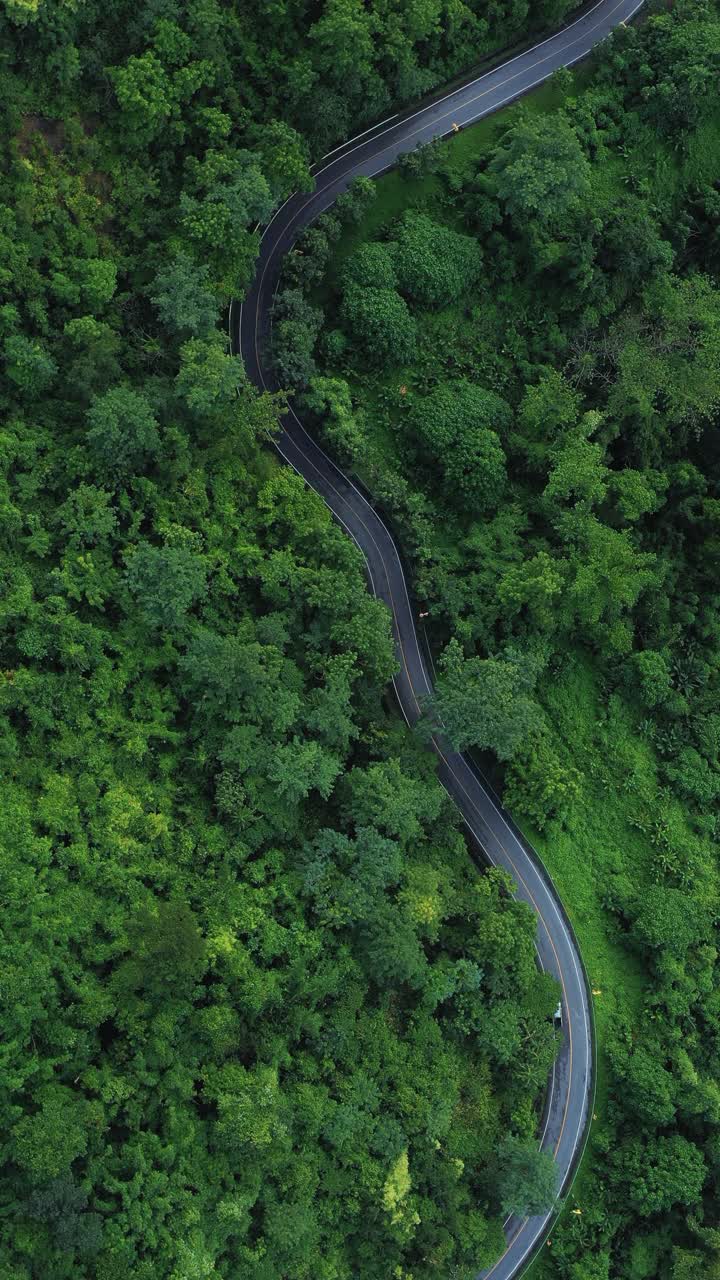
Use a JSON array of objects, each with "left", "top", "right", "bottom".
[{"left": 231, "top": 0, "right": 642, "bottom": 1280}]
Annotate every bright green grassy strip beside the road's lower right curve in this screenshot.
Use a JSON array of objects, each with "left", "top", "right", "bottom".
[{"left": 509, "top": 653, "right": 681, "bottom": 1280}]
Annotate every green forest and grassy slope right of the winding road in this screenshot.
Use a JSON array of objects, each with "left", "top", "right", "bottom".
[{"left": 275, "top": 0, "right": 720, "bottom": 1280}]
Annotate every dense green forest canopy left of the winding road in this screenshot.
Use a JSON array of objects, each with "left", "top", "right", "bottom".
[{"left": 0, "top": 0, "right": 589, "bottom": 1280}]
